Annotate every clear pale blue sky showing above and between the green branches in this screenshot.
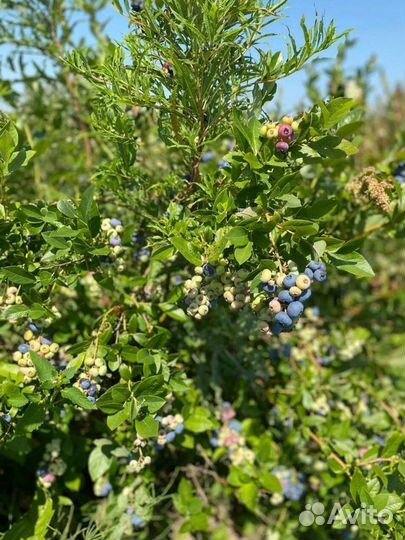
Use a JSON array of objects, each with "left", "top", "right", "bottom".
[{"left": 98, "top": 0, "right": 405, "bottom": 108}]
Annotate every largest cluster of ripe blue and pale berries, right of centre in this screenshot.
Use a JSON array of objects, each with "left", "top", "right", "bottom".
[{"left": 262, "top": 261, "right": 327, "bottom": 336}]
